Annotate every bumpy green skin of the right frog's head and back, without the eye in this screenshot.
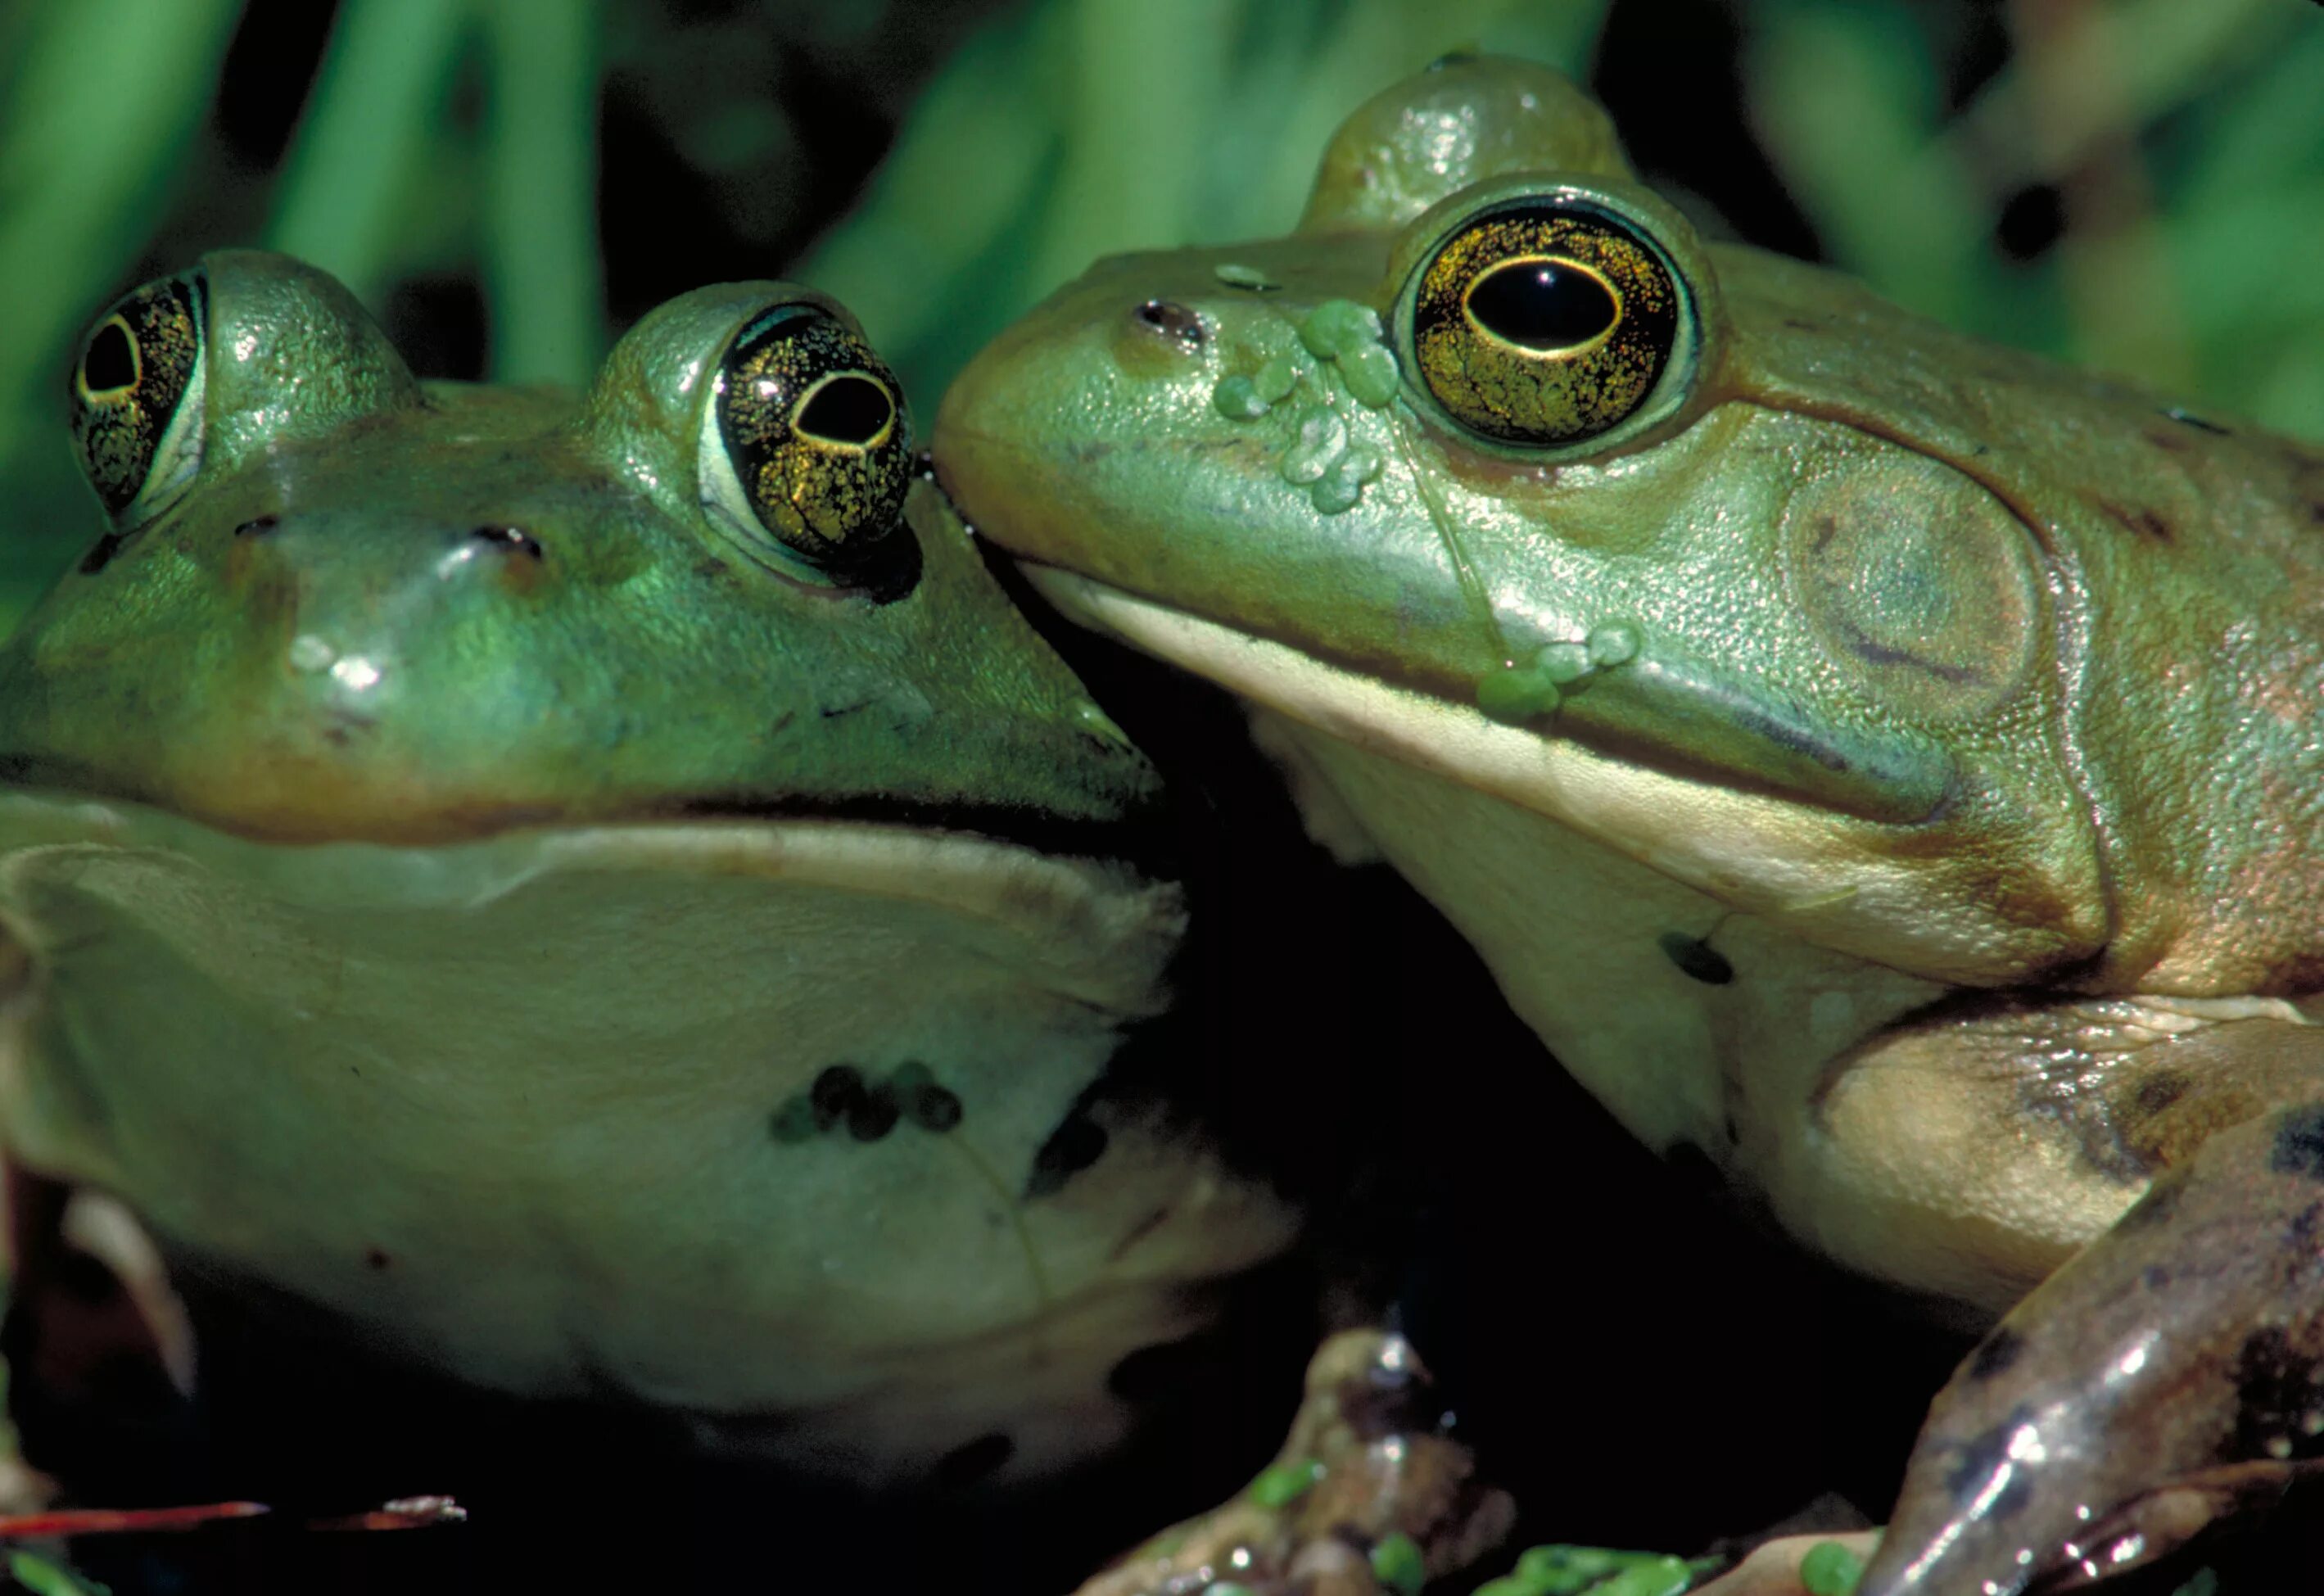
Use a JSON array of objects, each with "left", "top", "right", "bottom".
[{"left": 934, "top": 63, "right": 2324, "bottom": 994}]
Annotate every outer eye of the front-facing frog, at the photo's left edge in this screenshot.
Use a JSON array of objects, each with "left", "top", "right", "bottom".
[{"left": 72, "top": 272, "right": 205, "bottom": 525}]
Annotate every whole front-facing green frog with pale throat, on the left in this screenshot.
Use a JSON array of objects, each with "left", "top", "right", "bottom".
[{"left": 0, "top": 251, "right": 1295, "bottom": 1482}]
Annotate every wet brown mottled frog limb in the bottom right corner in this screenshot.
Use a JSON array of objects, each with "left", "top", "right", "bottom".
[{"left": 1859, "top": 1101, "right": 2324, "bottom": 1596}]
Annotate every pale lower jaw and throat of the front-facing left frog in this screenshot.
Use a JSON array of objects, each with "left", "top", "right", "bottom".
[{"left": 0, "top": 792, "right": 1218, "bottom": 1477}]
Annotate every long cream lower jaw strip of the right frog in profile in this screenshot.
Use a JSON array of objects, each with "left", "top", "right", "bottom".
[{"left": 1023, "top": 560, "right": 2087, "bottom": 985}]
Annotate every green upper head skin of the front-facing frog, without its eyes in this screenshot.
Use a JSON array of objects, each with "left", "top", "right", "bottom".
[{"left": 0, "top": 253, "right": 1155, "bottom": 841}]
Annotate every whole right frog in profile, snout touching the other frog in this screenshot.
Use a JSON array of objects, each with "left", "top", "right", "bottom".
[{"left": 934, "top": 58, "right": 2324, "bottom": 1596}]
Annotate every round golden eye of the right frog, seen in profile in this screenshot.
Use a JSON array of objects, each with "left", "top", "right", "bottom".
[{"left": 1406, "top": 192, "right": 1692, "bottom": 449}]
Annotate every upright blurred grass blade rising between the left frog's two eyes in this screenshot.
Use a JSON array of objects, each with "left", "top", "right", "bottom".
[{"left": 479, "top": 0, "right": 604, "bottom": 386}]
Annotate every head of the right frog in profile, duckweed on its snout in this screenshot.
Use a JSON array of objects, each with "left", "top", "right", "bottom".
[{"left": 937, "top": 61, "right": 2105, "bottom": 980}]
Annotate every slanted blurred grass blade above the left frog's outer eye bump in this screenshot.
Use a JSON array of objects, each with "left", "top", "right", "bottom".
[{"left": 267, "top": 0, "right": 469, "bottom": 305}]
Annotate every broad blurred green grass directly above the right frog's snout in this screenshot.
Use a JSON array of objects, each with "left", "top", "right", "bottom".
[{"left": 822, "top": 0, "right": 1606, "bottom": 401}]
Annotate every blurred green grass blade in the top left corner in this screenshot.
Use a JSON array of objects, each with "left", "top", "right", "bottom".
[{"left": 0, "top": 0, "right": 239, "bottom": 481}]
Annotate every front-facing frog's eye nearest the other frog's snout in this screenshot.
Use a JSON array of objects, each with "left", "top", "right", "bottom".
[{"left": 702, "top": 305, "right": 918, "bottom": 595}]
